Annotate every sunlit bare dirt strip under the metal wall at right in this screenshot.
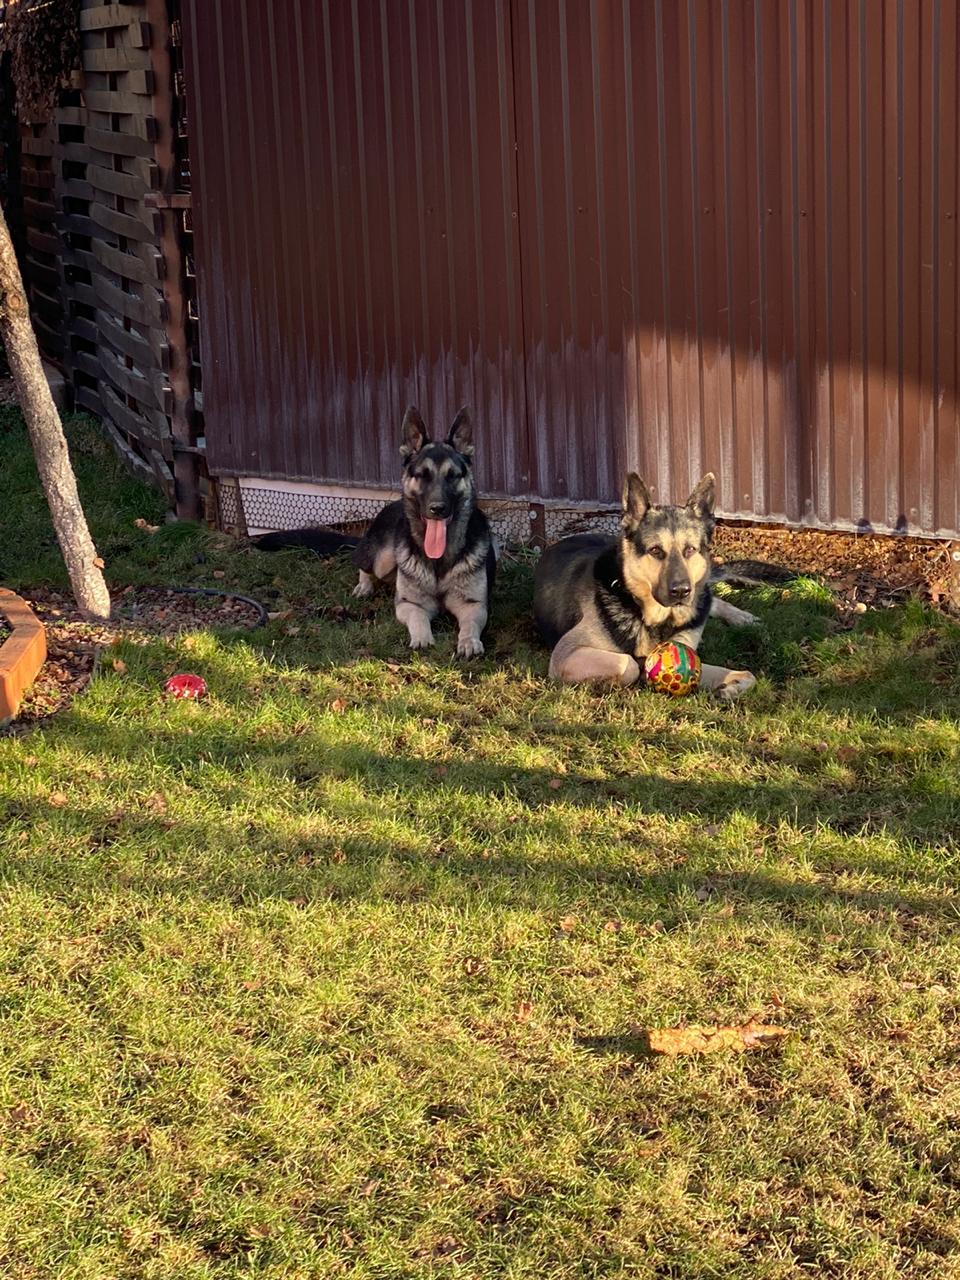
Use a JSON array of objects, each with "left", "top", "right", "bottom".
[{"left": 716, "top": 525, "right": 960, "bottom": 614}]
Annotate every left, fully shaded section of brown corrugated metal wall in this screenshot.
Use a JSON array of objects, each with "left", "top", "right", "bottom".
[{"left": 183, "top": 0, "right": 530, "bottom": 493}]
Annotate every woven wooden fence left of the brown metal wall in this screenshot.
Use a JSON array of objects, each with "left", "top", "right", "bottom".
[{"left": 0, "top": 0, "right": 202, "bottom": 516}]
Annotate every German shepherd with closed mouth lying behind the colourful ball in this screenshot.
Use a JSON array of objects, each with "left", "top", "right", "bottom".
[{"left": 534, "top": 472, "right": 792, "bottom": 699}]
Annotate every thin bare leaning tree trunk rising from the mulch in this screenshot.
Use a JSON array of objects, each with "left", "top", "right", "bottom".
[{"left": 0, "top": 210, "right": 110, "bottom": 618}]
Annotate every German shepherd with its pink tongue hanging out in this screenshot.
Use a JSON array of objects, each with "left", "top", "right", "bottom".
[{"left": 353, "top": 407, "right": 497, "bottom": 658}]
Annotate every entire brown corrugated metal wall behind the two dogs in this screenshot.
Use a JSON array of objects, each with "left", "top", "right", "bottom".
[{"left": 184, "top": 0, "right": 960, "bottom": 534}]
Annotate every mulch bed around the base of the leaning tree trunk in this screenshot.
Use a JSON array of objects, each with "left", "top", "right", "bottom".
[{"left": 3, "top": 586, "right": 267, "bottom": 733}]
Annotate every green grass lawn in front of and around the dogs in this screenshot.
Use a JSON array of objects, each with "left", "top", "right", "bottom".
[{"left": 0, "top": 411, "right": 960, "bottom": 1280}]
